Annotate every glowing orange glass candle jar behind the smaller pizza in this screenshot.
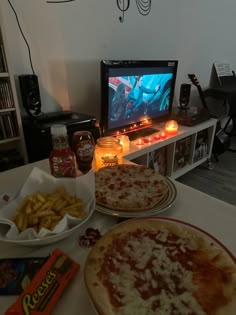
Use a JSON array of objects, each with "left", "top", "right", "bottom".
[{"left": 95, "top": 137, "right": 123, "bottom": 169}]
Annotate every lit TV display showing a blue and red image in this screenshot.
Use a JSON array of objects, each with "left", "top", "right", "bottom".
[{"left": 108, "top": 73, "right": 173, "bottom": 128}]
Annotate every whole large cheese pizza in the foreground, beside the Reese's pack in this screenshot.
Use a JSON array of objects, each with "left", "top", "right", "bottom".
[{"left": 85, "top": 218, "right": 236, "bottom": 315}]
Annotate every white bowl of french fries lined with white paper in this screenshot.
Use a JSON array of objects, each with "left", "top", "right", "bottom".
[{"left": 0, "top": 168, "right": 95, "bottom": 246}]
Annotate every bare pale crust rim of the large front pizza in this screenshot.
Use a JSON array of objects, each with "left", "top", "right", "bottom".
[{"left": 84, "top": 219, "right": 236, "bottom": 315}]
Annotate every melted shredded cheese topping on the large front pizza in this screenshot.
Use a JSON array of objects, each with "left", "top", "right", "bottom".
[{"left": 103, "top": 230, "right": 206, "bottom": 315}]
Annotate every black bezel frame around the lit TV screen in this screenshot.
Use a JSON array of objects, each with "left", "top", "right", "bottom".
[{"left": 100, "top": 60, "right": 178, "bottom": 136}]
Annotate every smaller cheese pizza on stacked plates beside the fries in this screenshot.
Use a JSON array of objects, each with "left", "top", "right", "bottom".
[{"left": 95, "top": 164, "right": 169, "bottom": 211}]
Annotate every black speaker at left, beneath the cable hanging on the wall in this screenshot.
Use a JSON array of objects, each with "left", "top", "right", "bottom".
[{"left": 19, "top": 74, "right": 41, "bottom": 116}]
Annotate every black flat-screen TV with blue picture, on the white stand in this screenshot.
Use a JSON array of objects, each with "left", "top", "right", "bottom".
[{"left": 100, "top": 60, "right": 178, "bottom": 138}]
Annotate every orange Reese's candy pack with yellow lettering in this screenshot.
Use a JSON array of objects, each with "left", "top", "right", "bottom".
[{"left": 5, "top": 248, "right": 80, "bottom": 315}]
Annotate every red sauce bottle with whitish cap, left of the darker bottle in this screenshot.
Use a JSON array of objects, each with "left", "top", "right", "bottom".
[{"left": 49, "top": 125, "right": 76, "bottom": 177}]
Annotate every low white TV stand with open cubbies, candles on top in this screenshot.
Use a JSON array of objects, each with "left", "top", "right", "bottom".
[{"left": 124, "top": 118, "right": 217, "bottom": 179}]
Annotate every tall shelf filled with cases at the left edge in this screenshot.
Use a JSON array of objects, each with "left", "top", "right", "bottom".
[{"left": 0, "top": 8, "right": 28, "bottom": 171}]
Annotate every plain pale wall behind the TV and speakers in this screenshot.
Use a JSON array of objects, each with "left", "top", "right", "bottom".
[{"left": 0, "top": 0, "right": 236, "bottom": 118}]
